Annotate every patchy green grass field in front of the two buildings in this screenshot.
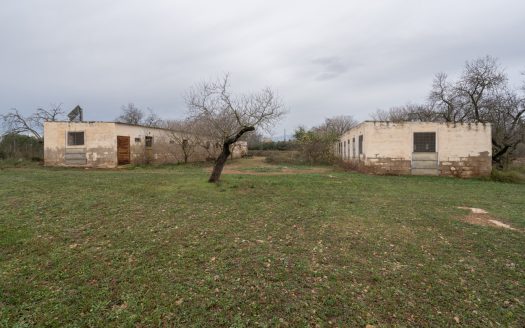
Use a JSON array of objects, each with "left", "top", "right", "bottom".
[{"left": 0, "top": 158, "right": 525, "bottom": 327}]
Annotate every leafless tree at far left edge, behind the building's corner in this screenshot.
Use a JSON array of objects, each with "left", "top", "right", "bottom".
[{"left": 1, "top": 105, "right": 64, "bottom": 142}]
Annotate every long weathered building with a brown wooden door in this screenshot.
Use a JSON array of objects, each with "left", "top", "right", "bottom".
[{"left": 44, "top": 122, "right": 247, "bottom": 168}]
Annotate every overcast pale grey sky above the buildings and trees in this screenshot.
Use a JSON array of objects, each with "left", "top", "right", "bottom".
[{"left": 0, "top": 0, "right": 525, "bottom": 135}]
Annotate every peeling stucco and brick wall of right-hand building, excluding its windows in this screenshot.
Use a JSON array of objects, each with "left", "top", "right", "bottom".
[{"left": 340, "top": 122, "right": 492, "bottom": 177}]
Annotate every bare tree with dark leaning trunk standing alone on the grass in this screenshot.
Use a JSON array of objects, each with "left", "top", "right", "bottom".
[{"left": 185, "top": 74, "right": 285, "bottom": 182}]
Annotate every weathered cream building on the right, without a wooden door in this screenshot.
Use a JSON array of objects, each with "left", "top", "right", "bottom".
[{"left": 336, "top": 121, "right": 492, "bottom": 177}]
